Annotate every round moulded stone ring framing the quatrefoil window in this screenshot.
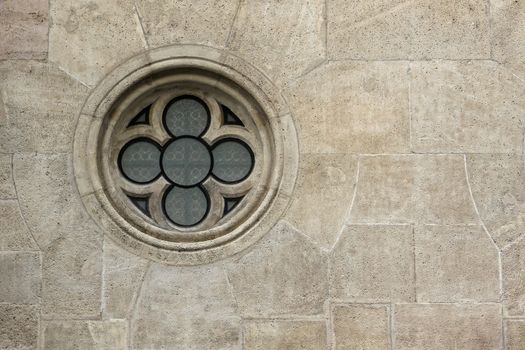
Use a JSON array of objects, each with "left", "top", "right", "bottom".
[{"left": 73, "top": 45, "right": 299, "bottom": 265}]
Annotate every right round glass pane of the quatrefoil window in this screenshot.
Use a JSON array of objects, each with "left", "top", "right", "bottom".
[{"left": 212, "top": 140, "right": 253, "bottom": 182}]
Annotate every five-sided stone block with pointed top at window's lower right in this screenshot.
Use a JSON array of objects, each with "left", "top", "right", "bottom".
[{"left": 228, "top": 222, "right": 328, "bottom": 317}]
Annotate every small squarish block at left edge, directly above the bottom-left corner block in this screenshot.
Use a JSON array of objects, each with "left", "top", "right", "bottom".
[{"left": 0, "top": 252, "right": 42, "bottom": 304}]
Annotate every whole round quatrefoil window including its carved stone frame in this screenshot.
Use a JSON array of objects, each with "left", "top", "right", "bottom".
[{"left": 74, "top": 47, "right": 297, "bottom": 264}]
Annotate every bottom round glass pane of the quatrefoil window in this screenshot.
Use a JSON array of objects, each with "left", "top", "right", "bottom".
[{"left": 163, "top": 186, "right": 208, "bottom": 226}]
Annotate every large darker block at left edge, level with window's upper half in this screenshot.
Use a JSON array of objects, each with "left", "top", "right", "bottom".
[{"left": 0, "top": 61, "right": 87, "bottom": 152}]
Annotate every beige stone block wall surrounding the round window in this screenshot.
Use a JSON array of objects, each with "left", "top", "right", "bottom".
[{"left": 0, "top": 0, "right": 525, "bottom": 350}]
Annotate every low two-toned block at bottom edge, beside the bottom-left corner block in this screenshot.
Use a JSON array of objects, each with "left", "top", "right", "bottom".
[{"left": 43, "top": 320, "right": 128, "bottom": 350}]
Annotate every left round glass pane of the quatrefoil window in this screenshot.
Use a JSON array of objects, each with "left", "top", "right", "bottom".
[{"left": 119, "top": 140, "right": 160, "bottom": 183}]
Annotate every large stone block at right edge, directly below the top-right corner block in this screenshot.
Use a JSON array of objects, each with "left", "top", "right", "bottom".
[{"left": 410, "top": 61, "right": 525, "bottom": 153}]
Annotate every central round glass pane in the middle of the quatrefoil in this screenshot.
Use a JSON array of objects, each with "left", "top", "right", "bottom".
[{"left": 162, "top": 137, "right": 212, "bottom": 187}]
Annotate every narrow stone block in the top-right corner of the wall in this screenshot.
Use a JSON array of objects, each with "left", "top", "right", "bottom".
[{"left": 490, "top": 0, "right": 525, "bottom": 79}]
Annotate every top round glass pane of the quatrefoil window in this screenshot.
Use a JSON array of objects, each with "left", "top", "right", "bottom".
[{"left": 164, "top": 97, "right": 210, "bottom": 136}]
